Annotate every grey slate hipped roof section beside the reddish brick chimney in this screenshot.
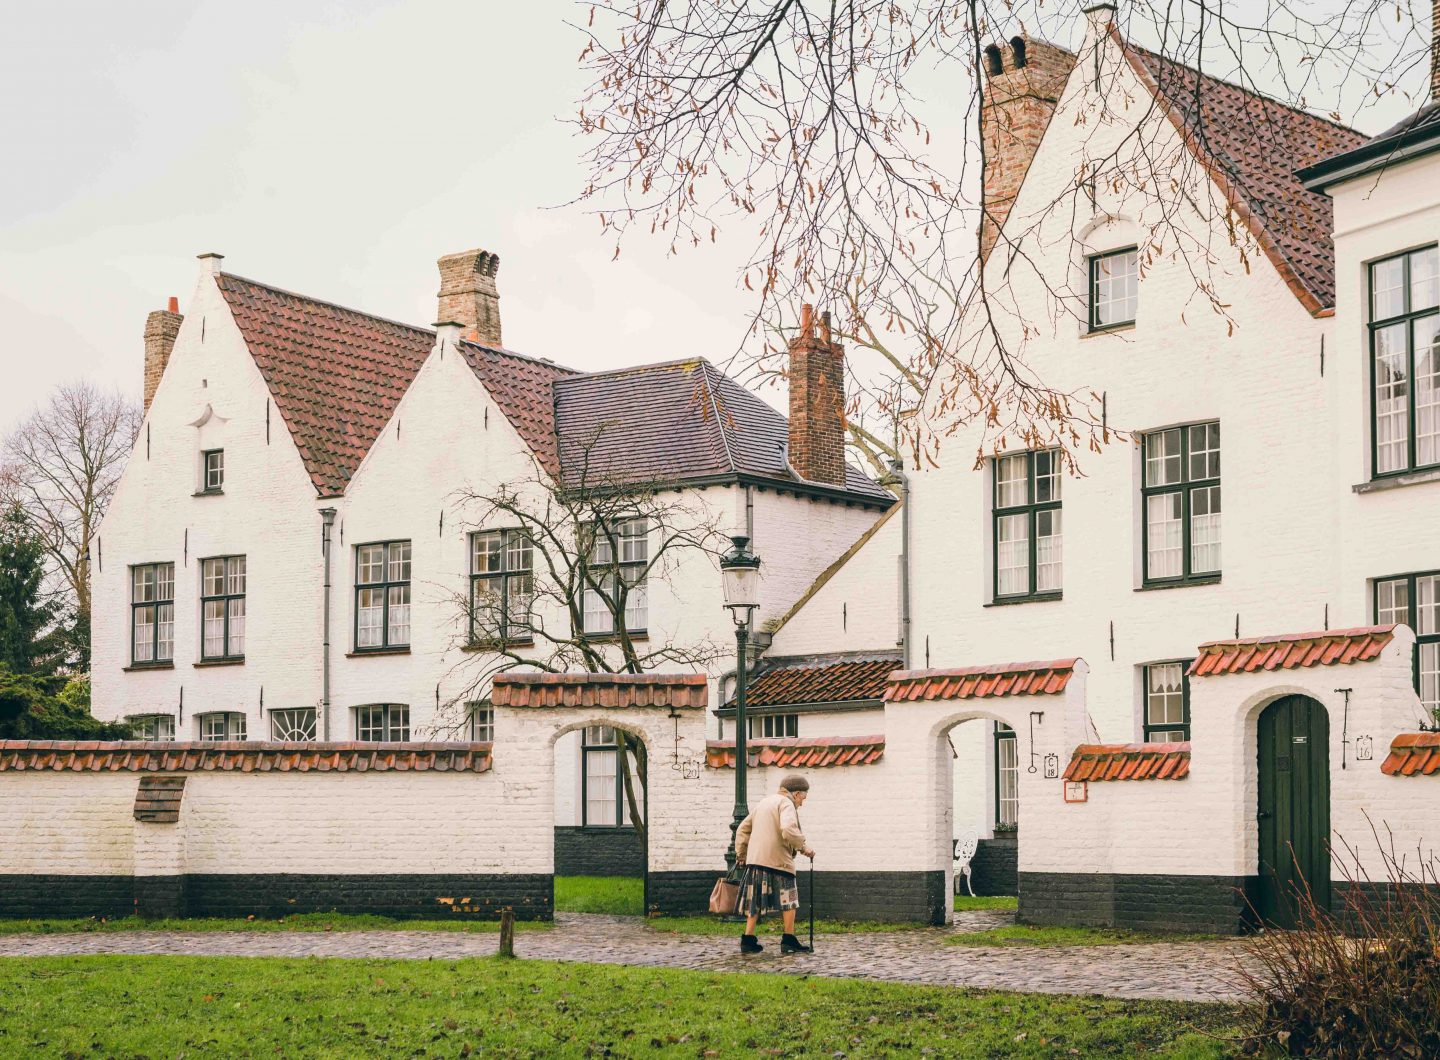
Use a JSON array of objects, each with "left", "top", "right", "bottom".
[{"left": 554, "top": 357, "right": 894, "bottom": 506}]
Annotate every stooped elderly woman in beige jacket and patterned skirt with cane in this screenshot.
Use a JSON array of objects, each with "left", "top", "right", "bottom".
[{"left": 734, "top": 775, "right": 815, "bottom": 953}]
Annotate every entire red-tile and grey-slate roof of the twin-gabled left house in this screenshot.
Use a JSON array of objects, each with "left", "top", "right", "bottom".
[{"left": 216, "top": 272, "right": 894, "bottom": 506}]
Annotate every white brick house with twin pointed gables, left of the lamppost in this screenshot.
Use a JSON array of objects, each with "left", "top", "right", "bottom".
[{"left": 92, "top": 251, "right": 894, "bottom": 869}]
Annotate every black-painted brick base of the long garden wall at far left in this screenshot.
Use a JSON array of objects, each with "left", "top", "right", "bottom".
[{"left": 0, "top": 873, "right": 552, "bottom": 920}]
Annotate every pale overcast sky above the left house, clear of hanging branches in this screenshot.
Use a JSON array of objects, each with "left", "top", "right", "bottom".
[{"left": 0, "top": 0, "right": 1416, "bottom": 432}]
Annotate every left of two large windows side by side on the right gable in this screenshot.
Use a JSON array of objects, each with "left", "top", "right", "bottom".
[{"left": 994, "top": 449, "right": 1063, "bottom": 599}]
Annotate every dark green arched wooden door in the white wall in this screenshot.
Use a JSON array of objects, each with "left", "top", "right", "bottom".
[{"left": 1256, "top": 696, "right": 1331, "bottom": 928}]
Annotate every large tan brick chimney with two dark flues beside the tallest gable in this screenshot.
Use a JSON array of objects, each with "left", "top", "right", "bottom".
[{"left": 981, "top": 37, "right": 1076, "bottom": 259}]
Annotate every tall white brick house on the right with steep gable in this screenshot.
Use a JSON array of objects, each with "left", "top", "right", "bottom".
[{"left": 757, "top": 4, "right": 1440, "bottom": 913}]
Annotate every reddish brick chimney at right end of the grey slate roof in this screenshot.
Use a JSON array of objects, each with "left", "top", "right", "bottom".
[{"left": 788, "top": 305, "right": 845, "bottom": 485}]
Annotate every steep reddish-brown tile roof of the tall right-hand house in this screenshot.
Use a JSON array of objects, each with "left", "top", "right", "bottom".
[{"left": 1125, "top": 43, "right": 1365, "bottom": 313}]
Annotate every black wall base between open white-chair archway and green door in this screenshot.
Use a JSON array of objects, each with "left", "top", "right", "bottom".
[{"left": 1018, "top": 873, "right": 1251, "bottom": 935}]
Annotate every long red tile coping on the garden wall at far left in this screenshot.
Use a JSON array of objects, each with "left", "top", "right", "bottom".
[{"left": 0, "top": 740, "right": 491, "bottom": 773}]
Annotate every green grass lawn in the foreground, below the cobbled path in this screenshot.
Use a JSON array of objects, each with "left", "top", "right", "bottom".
[{"left": 0, "top": 956, "right": 1240, "bottom": 1060}]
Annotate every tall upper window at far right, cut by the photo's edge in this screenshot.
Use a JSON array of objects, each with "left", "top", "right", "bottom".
[{"left": 1369, "top": 246, "right": 1440, "bottom": 475}]
